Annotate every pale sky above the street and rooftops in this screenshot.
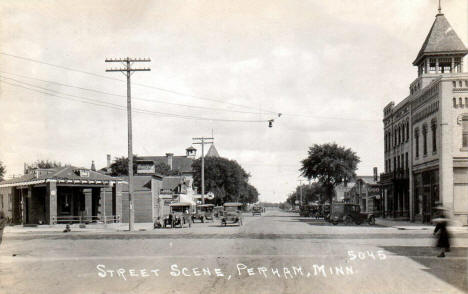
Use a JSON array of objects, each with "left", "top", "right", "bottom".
[{"left": 0, "top": 0, "right": 468, "bottom": 202}]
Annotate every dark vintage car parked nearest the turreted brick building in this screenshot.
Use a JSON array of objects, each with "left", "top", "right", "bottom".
[{"left": 330, "top": 203, "right": 375, "bottom": 225}]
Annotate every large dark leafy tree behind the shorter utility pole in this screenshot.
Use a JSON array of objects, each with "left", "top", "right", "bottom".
[{"left": 192, "top": 157, "right": 258, "bottom": 205}]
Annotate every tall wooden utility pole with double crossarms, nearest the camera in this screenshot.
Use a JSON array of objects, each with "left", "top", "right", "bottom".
[{"left": 106, "top": 57, "right": 151, "bottom": 231}]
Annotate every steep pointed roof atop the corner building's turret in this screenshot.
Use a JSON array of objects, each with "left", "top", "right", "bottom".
[{"left": 413, "top": 13, "right": 468, "bottom": 65}]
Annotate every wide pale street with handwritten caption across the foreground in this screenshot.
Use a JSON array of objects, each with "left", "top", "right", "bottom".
[{"left": 0, "top": 210, "right": 468, "bottom": 294}]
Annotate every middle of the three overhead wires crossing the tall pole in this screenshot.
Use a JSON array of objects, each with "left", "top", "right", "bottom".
[{"left": 0, "top": 70, "right": 267, "bottom": 114}]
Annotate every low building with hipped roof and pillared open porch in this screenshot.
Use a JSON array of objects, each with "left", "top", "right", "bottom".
[{"left": 0, "top": 166, "right": 123, "bottom": 224}]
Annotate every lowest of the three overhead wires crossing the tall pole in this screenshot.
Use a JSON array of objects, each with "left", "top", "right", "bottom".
[{"left": 0, "top": 76, "right": 267, "bottom": 123}]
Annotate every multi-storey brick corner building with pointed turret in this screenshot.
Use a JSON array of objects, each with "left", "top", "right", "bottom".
[{"left": 380, "top": 9, "right": 468, "bottom": 225}]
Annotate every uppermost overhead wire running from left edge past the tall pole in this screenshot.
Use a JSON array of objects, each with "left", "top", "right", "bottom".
[{"left": 0, "top": 52, "right": 280, "bottom": 115}]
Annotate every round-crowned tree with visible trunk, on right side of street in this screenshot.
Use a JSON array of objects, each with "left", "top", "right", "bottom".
[{"left": 300, "top": 143, "right": 360, "bottom": 203}]
